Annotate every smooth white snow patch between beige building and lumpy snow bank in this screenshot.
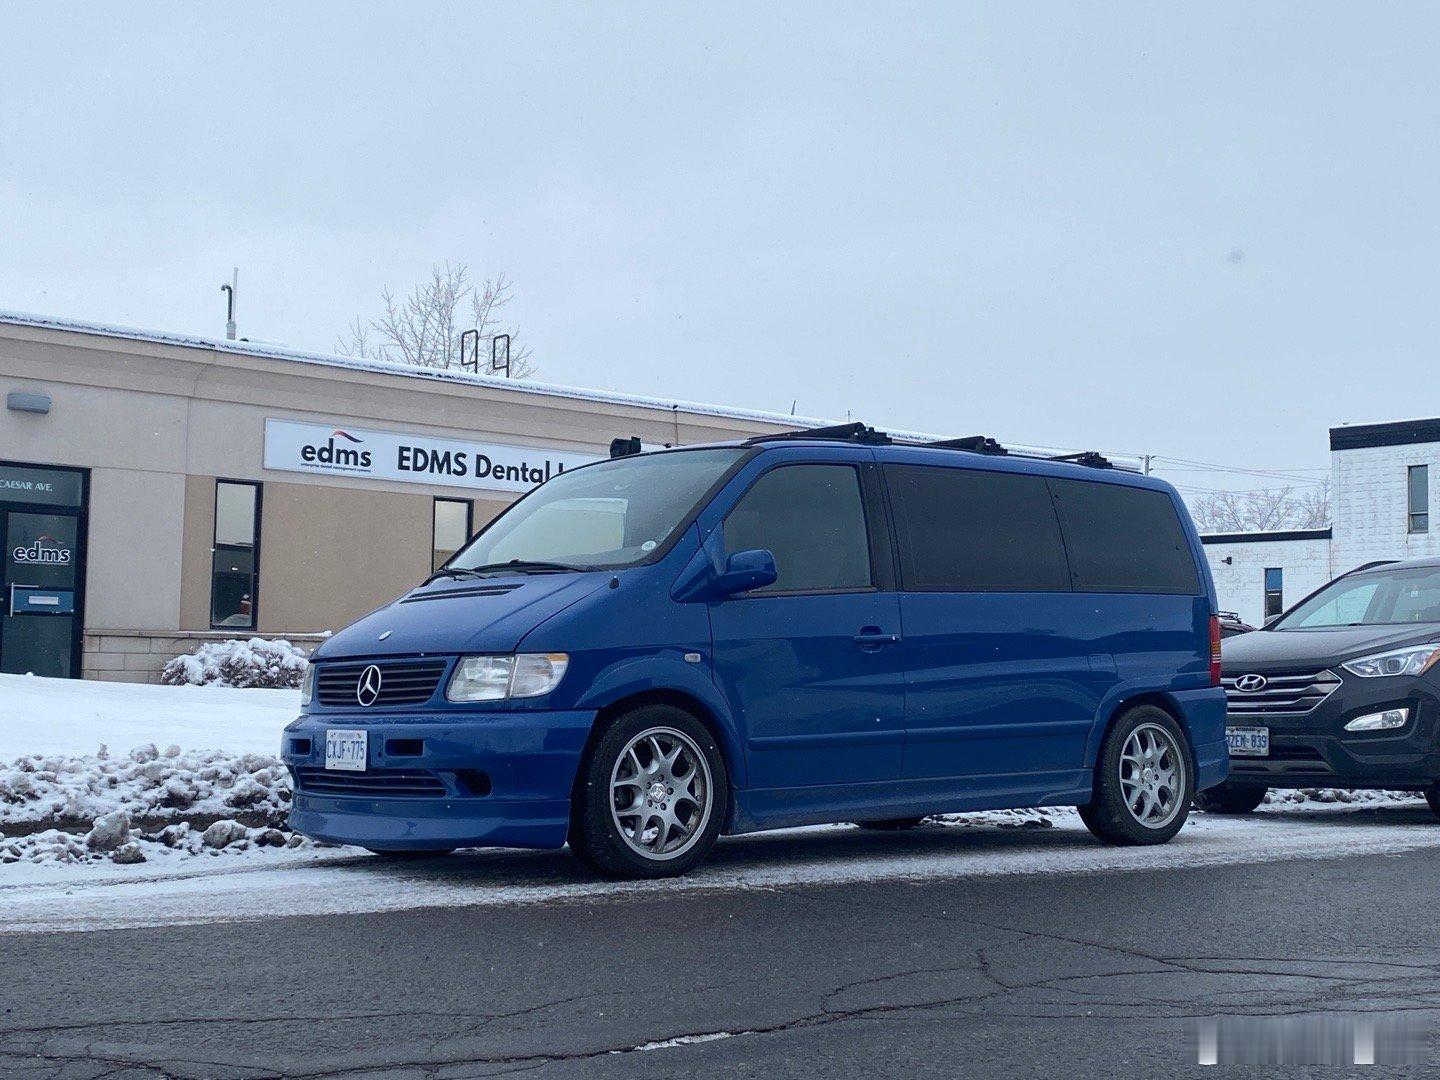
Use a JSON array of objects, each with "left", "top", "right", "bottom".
[{"left": 0, "top": 675, "right": 300, "bottom": 762}]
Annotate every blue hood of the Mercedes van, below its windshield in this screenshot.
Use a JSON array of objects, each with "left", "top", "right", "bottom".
[{"left": 315, "top": 573, "right": 611, "bottom": 660}]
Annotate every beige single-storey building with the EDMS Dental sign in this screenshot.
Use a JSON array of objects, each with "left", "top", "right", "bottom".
[{"left": 0, "top": 314, "right": 823, "bottom": 681}]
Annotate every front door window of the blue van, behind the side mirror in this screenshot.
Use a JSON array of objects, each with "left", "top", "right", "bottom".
[{"left": 724, "top": 465, "right": 871, "bottom": 595}]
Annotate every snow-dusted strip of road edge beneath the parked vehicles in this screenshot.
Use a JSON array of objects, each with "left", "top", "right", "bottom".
[{"left": 0, "top": 799, "right": 1440, "bottom": 933}]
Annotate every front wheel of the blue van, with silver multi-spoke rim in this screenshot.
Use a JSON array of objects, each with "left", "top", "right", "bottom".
[{"left": 570, "top": 706, "right": 729, "bottom": 877}]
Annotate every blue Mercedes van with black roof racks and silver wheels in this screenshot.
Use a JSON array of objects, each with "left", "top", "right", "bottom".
[{"left": 282, "top": 425, "right": 1230, "bottom": 877}]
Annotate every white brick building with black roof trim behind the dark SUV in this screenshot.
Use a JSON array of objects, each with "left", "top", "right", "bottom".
[{"left": 1204, "top": 419, "right": 1440, "bottom": 626}]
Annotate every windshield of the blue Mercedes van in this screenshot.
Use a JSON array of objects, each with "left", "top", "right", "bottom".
[{"left": 445, "top": 446, "right": 747, "bottom": 570}]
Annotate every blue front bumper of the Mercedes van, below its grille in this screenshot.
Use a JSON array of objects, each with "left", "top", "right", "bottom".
[{"left": 281, "top": 711, "right": 595, "bottom": 851}]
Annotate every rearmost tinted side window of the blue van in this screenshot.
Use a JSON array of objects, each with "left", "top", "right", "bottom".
[{"left": 1050, "top": 480, "right": 1200, "bottom": 595}]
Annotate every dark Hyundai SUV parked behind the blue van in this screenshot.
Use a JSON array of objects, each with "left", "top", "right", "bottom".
[{"left": 1197, "top": 559, "right": 1440, "bottom": 814}]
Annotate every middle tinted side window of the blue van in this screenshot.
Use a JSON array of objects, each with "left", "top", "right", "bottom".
[{"left": 884, "top": 465, "right": 1070, "bottom": 592}]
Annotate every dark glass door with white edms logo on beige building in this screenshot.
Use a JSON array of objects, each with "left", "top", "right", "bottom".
[{"left": 0, "top": 510, "right": 81, "bottom": 678}]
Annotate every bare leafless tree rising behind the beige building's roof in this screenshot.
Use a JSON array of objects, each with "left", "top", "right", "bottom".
[{"left": 336, "top": 262, "right": 534, "bottom": 379}]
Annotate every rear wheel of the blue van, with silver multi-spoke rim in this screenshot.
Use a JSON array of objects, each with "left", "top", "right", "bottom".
[{"left": 1080, "top": 706, "right": 1194, "bottom": 844}]
